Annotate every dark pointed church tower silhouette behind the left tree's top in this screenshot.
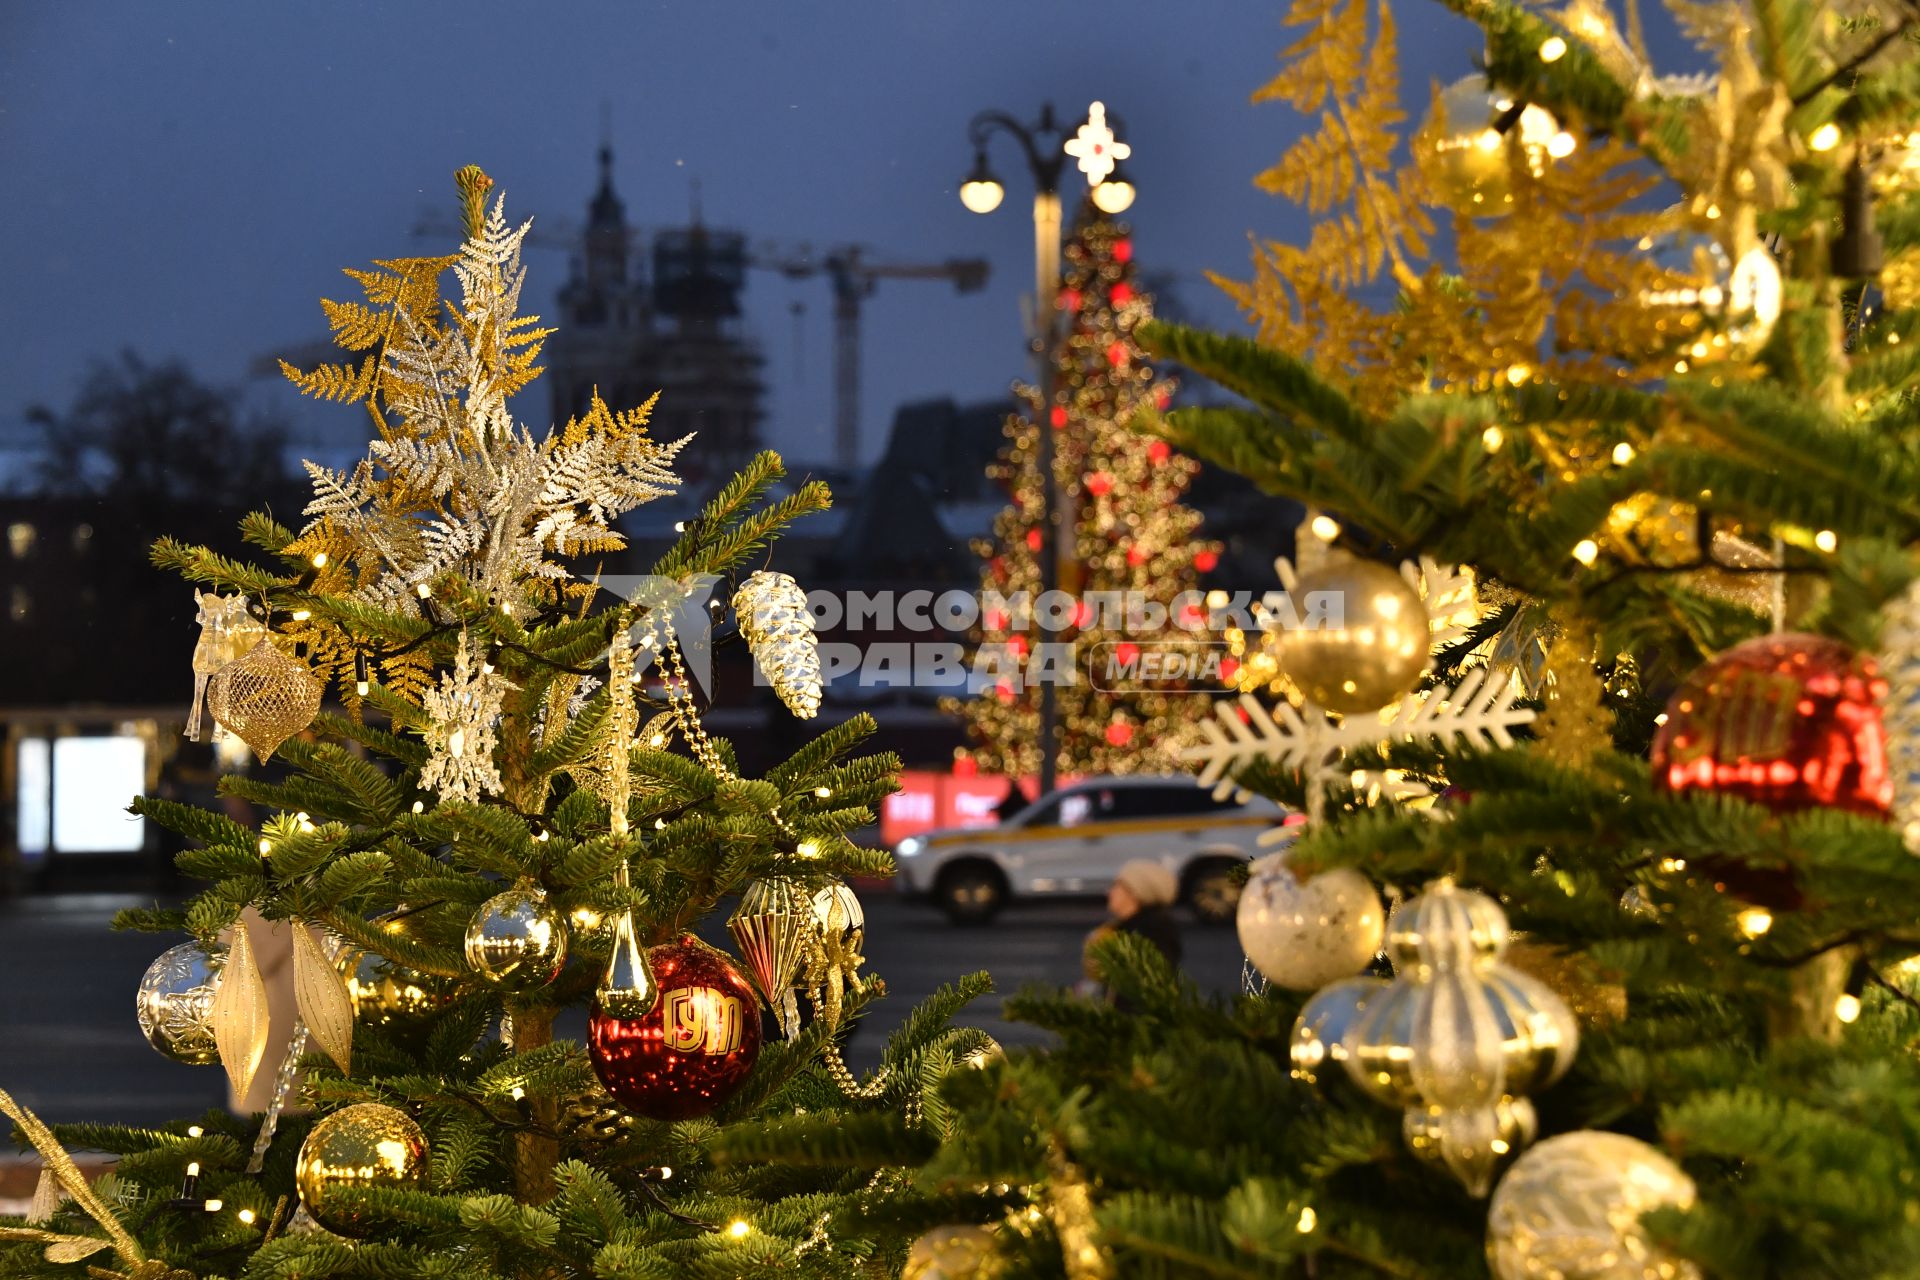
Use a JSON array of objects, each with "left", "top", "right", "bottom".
[{"left": 547, "top": 146, "right": 657, "bottom": 422}]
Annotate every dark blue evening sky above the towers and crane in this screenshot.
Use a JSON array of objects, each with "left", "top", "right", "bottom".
[{"left": 0, "top": 0, "right": 1674, "bottom": 470}]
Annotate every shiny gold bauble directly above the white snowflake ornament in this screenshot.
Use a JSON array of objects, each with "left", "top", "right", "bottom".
[{"left": 1281, "top": 557, "right": 1428, "bottom": 716}]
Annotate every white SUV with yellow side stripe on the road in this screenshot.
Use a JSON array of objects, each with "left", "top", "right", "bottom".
[{"left": 893, "top": 775, "right": 1288, "bottom": 925}]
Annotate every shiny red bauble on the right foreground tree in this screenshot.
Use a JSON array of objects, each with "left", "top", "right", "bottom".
[{"left": 1653, "top": 633, "right": 1893, "bottom": 816}]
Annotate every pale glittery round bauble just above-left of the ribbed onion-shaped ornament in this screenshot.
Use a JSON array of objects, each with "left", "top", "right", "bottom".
[{"left": 1235, "top": 852, "right": 1386, "bottom": 990}]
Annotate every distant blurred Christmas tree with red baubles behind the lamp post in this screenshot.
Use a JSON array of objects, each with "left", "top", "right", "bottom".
[{"left": 948, "top": 201, "right": 1223, "bottom": 779}]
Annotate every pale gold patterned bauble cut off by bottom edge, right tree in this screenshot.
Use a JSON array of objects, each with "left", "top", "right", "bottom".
[{"left": 1486, "top": 1128, "right": 1701, "bottom": 1280}]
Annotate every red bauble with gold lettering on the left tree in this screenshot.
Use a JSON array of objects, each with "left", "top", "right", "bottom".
[{"left": 588, "top": 936, "right": 760, "bottom": 1121}]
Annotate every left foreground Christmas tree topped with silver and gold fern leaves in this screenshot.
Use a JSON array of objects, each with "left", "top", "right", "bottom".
[{"left": 0, "top": 169, "right": 991, "bottom": 1280}]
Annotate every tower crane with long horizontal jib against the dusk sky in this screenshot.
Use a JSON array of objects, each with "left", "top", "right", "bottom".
[{"left": 413, "top": 215, "right": 989, "bottom": 468}]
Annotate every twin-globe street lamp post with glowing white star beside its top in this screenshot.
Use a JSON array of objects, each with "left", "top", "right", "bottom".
[{"left": 960, "top": 102, "right": 1133, "bottom": 796}]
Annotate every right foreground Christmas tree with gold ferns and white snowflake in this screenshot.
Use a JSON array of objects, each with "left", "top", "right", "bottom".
[{"left": 744, "top": 0, "right": 1920, "bottom": 1280}]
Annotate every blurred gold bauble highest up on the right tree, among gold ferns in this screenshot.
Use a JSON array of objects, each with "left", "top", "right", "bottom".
[{"left": 1413, "top": 75, "right": 1563, "bottom": 217}]
